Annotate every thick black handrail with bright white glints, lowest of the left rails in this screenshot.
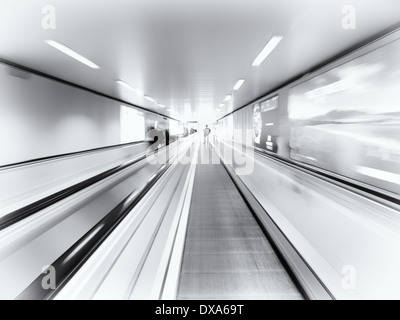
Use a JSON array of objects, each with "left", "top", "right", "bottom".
[{"left": 16, "top": 164, "right": 171, "bottom": 300}]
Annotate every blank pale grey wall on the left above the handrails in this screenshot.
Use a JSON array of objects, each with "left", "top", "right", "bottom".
[{"left": 0, "top": 65, "right": 121, "bottom": 166}]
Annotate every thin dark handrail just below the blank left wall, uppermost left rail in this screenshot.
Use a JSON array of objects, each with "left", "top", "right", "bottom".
[{"left": 0, "top": 141, "right": 146, "bottom": 170}]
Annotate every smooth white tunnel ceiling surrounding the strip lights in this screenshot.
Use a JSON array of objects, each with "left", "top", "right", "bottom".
[{"left": 0, "top": 0, "right": 400, "bottom": 119}]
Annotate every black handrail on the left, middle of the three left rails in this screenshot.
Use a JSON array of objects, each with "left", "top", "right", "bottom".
[{"left": 0, "top": 154, "right": 146, "bottom": 230}]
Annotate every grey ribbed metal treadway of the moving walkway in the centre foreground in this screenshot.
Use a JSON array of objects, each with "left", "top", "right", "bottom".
[{"left": 178, "top": 148, "right": 303, "bottom": 300}]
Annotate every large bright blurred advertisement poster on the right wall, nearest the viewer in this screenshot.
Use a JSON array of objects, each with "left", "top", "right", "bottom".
[{"left": 288, "top": 41, "right": 400, "bottom": 193}]
